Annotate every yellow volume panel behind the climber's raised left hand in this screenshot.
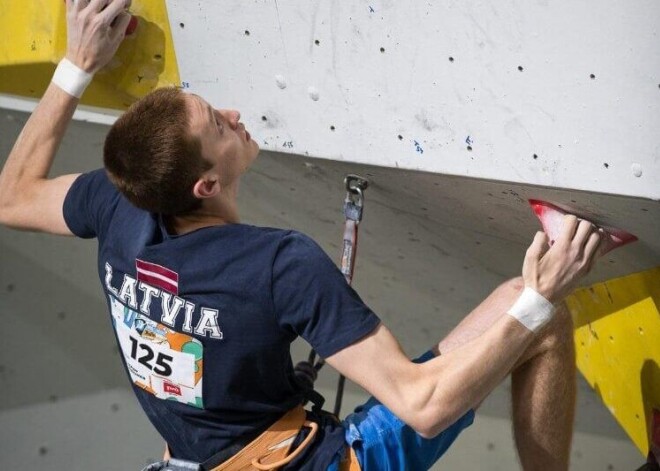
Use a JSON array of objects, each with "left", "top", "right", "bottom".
[{"left": 0, "top": 0, "right": 180, "bottom": 110}]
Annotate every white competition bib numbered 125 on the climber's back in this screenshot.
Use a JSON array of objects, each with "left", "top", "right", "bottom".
[{"left": 108, "top": 295, "right": 203, "bottom": 408}]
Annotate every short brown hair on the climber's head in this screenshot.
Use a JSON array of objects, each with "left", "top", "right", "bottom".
[{"left": 103, "top": 87, "right": 211, "bottom": 215}]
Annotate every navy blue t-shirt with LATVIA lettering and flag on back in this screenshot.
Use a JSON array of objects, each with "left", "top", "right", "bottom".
[{"left": 63, "top": 170, "right": 379, "bottom": 470}]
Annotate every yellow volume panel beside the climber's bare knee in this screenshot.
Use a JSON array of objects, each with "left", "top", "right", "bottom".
[{"left": 567, "top": 267, "right": 660, "bottom": 456}]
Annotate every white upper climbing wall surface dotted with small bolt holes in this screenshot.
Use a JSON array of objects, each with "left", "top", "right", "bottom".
[{"left": 167, "top": 0, "right": 660, "bottom": 200}]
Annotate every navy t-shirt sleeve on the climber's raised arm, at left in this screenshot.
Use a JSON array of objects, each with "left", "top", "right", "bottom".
[{"left": 62, "top": 169, "right": 119, "bottom": 239}]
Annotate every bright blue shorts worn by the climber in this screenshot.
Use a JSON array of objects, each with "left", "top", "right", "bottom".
[{"left": 328, "top": 352, "right": 474, "bottom": 471}]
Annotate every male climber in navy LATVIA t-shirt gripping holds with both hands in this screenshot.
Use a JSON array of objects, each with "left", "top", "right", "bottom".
[{"left": 0, "top": 0, "right": 600, "bottom": 471}]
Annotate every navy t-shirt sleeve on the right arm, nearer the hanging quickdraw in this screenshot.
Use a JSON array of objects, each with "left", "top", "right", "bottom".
[{"left": 272, "top": 232, "right": 380, "bottom": 358}]
